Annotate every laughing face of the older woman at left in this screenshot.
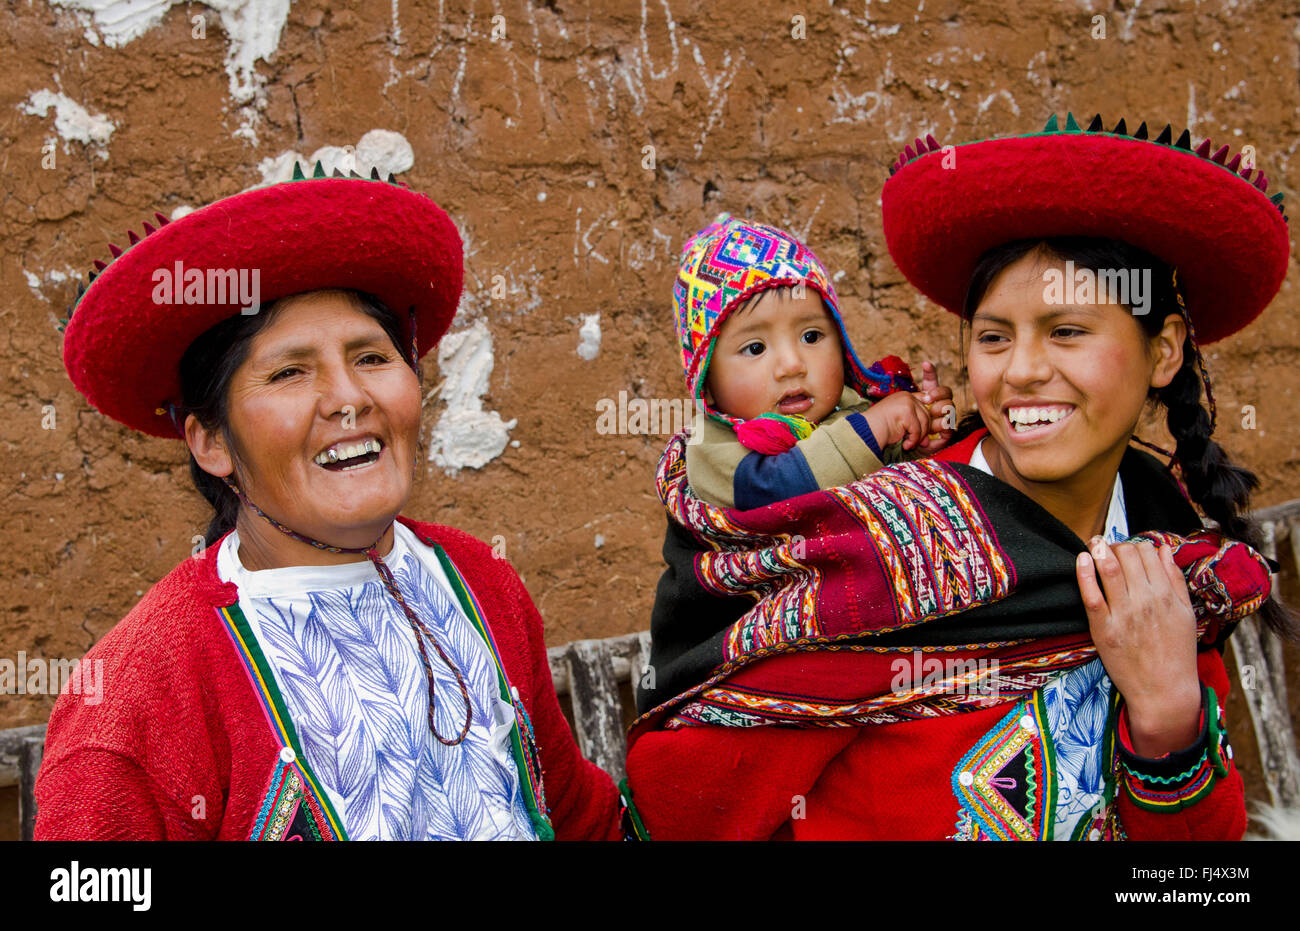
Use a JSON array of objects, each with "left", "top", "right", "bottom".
[{"left": 189, "top": 291, "right": 420, "bottom": 547}]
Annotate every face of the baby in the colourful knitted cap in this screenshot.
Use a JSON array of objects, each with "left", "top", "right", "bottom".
[{"left": 705, "top": 287, "right": 844, "bottom": 424}]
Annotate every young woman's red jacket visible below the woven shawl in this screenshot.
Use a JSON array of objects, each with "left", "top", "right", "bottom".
[{"left": 628, "top": 430, "right": 1247, "bottom": 840}]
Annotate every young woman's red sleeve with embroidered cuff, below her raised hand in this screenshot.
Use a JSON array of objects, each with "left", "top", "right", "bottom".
[{"left": 1117, "top": 650, "right": 1245, "bottom": 840}]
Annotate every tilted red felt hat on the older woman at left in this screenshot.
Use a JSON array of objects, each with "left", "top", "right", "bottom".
[{"left": 64, "top": 163, "right": 464, "bottom": 438}]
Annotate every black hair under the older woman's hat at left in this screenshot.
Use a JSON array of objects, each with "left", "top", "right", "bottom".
[{"left": 178, "top": 291, "right": 420, "bottom": 546}]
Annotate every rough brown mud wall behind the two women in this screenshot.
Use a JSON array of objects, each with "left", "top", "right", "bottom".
[{"left": 0, "top": 0, "right": 1300, "bottom": 816}]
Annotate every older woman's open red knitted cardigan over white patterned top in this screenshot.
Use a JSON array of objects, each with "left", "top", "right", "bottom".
[{"left": 35, "top": 518, "right": 621, "bottom": 840}]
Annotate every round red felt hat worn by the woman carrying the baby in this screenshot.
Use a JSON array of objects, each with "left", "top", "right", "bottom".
[{"left": 881, "top": 114, "right": 1291, "bottom": 343}]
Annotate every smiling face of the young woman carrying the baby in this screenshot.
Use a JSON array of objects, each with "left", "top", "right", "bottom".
[{"left": 967, "top": 248, "right": 1186, "bottom": 497}]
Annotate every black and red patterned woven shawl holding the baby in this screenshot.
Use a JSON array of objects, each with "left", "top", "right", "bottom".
[{"left": 634, "top": 426, "right": 1270, "bottom": 736}]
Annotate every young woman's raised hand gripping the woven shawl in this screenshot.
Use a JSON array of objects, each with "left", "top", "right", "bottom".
[{"left": 1075, "top": 537, "right": 1201, "bottom": 758}]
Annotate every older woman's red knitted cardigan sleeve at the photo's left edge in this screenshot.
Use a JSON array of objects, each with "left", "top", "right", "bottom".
[{"left": 35, "top": 566, "right": 243, "bottom": 840}]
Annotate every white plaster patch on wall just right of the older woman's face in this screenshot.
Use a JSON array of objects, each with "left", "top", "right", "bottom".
[{"left": 429, "top": 320, "right": 517, "bottom": 476}]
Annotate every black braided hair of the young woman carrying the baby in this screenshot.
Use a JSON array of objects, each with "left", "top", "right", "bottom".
[{"left": 953, "top": 237, "right": 1300, "bottom": 641}]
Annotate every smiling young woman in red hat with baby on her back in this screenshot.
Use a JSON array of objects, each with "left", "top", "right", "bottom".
[{"left": 628, "top": 117, "right": 1294, "bottom": 840}]
